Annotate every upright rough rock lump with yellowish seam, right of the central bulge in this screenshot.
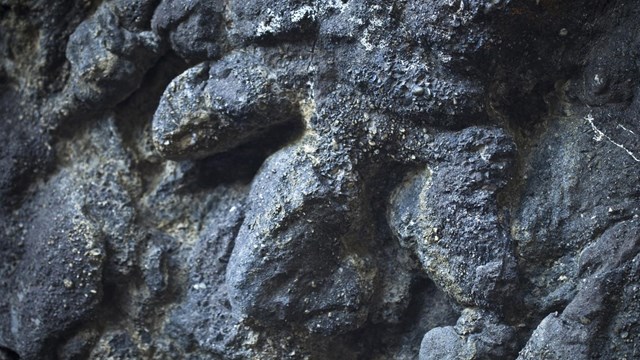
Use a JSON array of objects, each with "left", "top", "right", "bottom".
[{"left": 389, "top": 128, "right": 516, "bottom": 308}]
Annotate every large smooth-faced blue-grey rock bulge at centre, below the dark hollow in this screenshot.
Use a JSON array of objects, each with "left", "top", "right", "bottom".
[{"left": 227, "top": 140, "right": 376, "bottom": 333}]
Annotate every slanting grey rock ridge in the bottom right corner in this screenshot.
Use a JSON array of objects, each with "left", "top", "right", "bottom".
[{"left": 518, "top": 218, "right": 640, "bottom": 360}]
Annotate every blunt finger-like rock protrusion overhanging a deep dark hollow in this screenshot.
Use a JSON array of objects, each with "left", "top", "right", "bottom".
[{"left": 152, "top": 50, "right": 302, "bottom": 159}]
